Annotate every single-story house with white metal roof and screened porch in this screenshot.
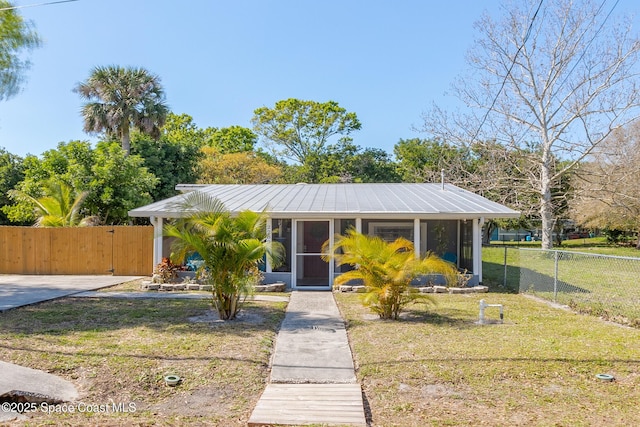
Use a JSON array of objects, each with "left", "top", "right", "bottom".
[{"left": 129, "top": 183, "right": 520, "bottom": 290}]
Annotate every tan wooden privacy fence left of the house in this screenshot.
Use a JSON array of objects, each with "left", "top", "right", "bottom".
[{"left": 0, "top": 226, "right": 153, "bottom": 276}]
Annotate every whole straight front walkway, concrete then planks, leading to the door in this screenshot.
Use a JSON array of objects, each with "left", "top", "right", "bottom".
[{"left": 248, "top": 291, "right": 367, "bottom": 426}]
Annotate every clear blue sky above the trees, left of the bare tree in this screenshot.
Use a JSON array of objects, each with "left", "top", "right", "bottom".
[{"left": 0, "top": 0, "right": 629, "bottom": 160}]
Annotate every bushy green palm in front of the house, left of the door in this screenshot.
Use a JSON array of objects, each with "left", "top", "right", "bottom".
[{"left": 164, "top": 191, "right": 284, "bottom": 320}]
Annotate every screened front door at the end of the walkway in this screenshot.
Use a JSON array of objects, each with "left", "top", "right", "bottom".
[{"left": 294, "top": 220, "right": 332, "bottom": 290}]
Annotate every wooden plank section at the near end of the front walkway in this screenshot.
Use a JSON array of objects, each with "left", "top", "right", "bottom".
[{"left": 248, "top": 384, "right": 367, "bottom": 427}]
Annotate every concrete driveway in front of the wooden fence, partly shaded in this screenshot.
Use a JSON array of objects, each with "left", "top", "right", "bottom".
[{"left": 0, "top": 274, "right": 142, "bottom": 312}]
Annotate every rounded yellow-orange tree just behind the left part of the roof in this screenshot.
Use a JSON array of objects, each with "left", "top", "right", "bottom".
[{"left": 197, "top": 147, "right": 282, "bottom": 184}]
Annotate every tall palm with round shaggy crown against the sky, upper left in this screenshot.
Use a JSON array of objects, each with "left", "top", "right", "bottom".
[{"left": 74, "top": 66, "right": 169, "bottom": 155}]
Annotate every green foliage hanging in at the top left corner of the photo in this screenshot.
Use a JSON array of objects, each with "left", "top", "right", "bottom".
[{"left": 0, "top": 0, "right": 41, "bottom": 100}]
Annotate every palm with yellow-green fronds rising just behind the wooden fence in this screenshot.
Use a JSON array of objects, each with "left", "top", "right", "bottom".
[{"left": 9, "top": 181, "right": 93, "bottom": 227}]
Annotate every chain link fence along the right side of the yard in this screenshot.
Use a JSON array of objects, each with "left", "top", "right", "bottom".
[{"left": 503, "top": 247, "right": 640, "bottom": 327}]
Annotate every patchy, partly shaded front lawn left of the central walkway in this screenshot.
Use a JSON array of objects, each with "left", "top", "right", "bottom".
[{"left": 0, "top": 292, "right": 286, "bottom": 426}]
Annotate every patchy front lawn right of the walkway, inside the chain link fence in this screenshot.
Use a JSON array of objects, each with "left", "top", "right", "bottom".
[{"left": 336, "top": 293, "right": 640, "bottom": 427}]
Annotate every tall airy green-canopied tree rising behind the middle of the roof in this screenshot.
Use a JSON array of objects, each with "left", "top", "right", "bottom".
[{"left": 251, "top": 98, "right": 361, "bottom": 182}]
